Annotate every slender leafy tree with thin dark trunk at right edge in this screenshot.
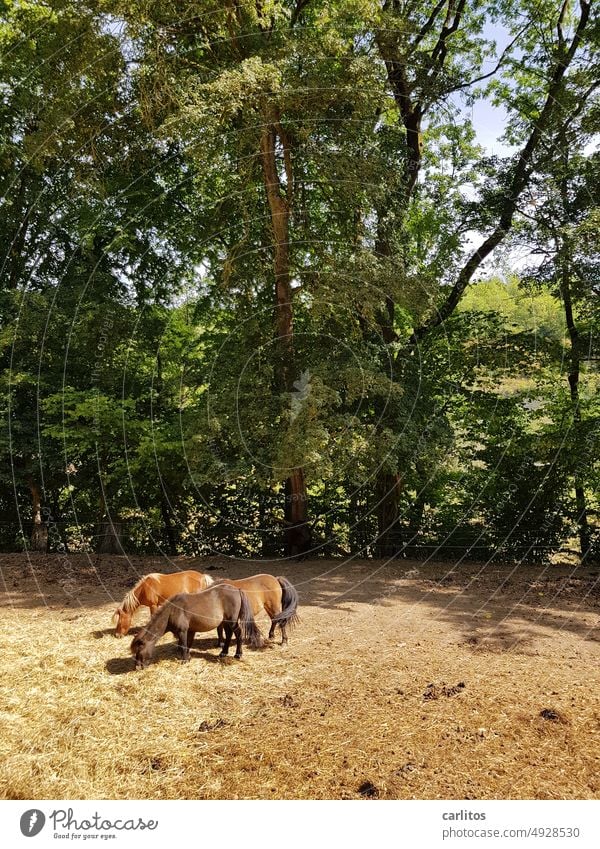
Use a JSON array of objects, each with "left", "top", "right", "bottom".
[{"left": 522, "top": 137, "right": 599, "bottom": 560}]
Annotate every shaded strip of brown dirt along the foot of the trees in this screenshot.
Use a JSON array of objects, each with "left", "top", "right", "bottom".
[{"left": 0, "top": 555, "right": 600, "bottom": 648}]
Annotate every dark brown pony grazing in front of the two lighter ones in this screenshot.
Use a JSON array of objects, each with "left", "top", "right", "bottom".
[{"left": 131, "top": 583, "right": 264, "bottom": 669}]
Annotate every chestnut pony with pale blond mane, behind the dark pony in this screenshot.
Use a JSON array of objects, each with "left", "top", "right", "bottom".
[{"left": 114, "top": 569, "right": 214, "bottom": 637}]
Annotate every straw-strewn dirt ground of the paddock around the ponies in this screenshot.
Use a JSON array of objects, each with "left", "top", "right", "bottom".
[{"left": 0, "top": 555, "right": 600, "bottom": 799}]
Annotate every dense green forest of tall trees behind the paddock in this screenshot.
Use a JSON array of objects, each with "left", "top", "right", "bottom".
[{"left": 0, "top": 0, "right": 600, "bottom": 563}]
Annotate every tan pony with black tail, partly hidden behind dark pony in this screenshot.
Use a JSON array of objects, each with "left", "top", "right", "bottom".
[{"left": 216, "top": 575, "right": 299, "bottom": 646}]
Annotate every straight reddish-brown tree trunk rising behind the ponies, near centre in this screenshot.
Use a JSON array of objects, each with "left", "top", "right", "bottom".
[{"left": 260, "top": 109, "right": 312, "bottom": 557}]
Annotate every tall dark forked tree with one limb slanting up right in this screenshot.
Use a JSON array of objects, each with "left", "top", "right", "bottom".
[{"left": 376, "top": 0, "right": 597, "bottom": 554}]
